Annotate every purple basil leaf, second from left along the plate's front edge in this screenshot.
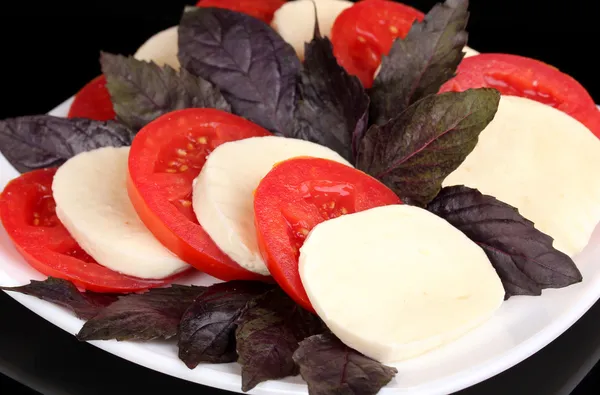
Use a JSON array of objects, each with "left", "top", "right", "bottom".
[{"left": 77, "top": 285, "right": 206, "bottom": 341}]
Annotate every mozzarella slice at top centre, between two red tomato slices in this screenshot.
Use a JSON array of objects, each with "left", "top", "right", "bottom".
[{"left": 271, "top": 0, "right": 354, "bottom": 60}]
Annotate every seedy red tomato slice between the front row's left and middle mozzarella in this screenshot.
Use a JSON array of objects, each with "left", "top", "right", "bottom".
[{"left": 127, "top": 108, "right": 271, "bottom": 281}]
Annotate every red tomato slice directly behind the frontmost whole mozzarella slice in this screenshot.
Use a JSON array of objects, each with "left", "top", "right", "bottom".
[{"left": 254, "top": 157, "right": 402, "bottom": 312}]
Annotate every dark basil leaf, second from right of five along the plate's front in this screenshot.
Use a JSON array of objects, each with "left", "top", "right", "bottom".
[{"left": 235, "top": 288, "right": 327, "bottom": 392}]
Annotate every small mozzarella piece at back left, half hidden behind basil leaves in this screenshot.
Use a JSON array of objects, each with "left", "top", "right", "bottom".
[{"left": 133, "top": 26, "right": 181, "bottom": 70}]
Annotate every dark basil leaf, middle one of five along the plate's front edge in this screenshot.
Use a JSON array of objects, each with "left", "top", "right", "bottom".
[{"left": 178, "top": 281, "right": 272, "bottom": 369}]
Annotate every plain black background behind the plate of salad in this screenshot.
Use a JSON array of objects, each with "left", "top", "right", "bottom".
[{"left": 0, "top": 0, "right": 600, "bottom": 395}]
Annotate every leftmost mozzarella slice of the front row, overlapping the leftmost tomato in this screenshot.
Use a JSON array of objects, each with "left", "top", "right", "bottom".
[{"left": 52, "top": 147, "right": 189, "bottom": 279}]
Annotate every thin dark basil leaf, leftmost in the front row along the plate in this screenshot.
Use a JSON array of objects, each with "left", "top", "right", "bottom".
[{"left": 0, "top": 277, "right": 117, "bottom": 320}]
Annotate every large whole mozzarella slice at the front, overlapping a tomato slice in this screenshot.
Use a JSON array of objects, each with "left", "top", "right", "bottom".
[{"left": 299, "top": 205, "right": 504, "bottom": 363}]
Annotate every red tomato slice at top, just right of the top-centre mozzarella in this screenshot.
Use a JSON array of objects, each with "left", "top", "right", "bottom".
[{"left": 331, "top": 0, "right": 425, "bottom": 88}]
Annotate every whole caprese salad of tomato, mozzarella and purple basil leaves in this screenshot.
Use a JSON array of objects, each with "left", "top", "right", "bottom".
[{"left": 0, "top": 0, "right": 600, "bottom": 395}]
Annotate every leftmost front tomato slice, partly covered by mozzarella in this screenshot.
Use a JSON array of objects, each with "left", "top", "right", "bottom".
[{"left": 0, "top": 168, "right": 181, "bottom": 293}]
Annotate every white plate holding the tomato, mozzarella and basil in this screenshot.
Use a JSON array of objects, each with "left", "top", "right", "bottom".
[{"left": 0, "top": 99, "right": 600, "bottom": 395}]
